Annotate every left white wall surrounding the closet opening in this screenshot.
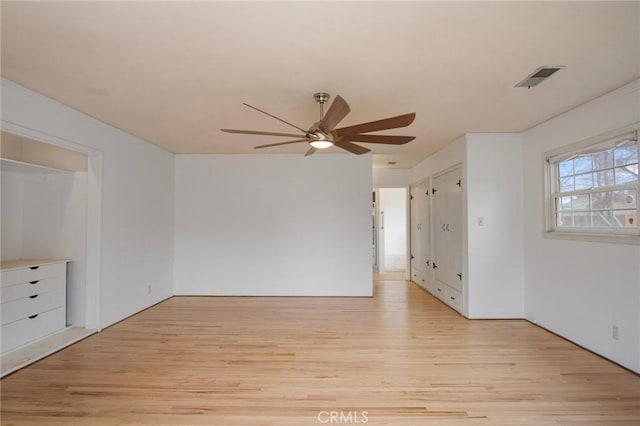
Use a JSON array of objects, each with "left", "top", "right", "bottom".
[{"left": 2, "top": 79, "right": 174, "bottom": 327}]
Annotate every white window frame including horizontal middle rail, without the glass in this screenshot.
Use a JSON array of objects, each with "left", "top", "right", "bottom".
[{"left": 543, "top": 122, "right": 640, "bottom": 245}]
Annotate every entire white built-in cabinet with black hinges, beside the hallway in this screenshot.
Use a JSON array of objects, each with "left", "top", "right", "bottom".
[{"left": 410, "top": 167, "right": 464, "bottom": 313}]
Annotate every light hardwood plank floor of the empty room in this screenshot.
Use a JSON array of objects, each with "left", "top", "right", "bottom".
[{"left": 1, "top": 281, "right": 640, "bottom": 426}]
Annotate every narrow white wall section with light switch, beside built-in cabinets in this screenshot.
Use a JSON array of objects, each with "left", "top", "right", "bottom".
[{"left": 466, "top": 133, "right": 524, "bottom": 318}]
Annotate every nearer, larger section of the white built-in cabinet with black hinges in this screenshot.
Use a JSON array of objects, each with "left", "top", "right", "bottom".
[{"left": 432, "top": 168, "right": 463, "bottom": 312}]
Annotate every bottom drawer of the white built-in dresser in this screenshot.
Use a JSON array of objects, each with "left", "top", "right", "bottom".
[{"left": 2, "top": 308, "right": 65, "bottom": 353}]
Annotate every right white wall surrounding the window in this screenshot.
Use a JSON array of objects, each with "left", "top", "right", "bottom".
[{"left": 523, "top": 81, "right": 640, "bottom": 371}]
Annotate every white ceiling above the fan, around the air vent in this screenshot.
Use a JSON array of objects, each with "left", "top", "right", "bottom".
[{"left": 2, "top": 1, "right": 640, "bottom": 168}]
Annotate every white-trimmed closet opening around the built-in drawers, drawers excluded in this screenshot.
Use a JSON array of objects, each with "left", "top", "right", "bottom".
[{"left": 0, "top": 128, "right": 102, "bottom": 376}]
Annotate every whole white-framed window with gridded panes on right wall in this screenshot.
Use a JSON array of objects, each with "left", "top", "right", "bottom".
[{"left": 546, "top": 128, "right": 640, "bottom": 241}]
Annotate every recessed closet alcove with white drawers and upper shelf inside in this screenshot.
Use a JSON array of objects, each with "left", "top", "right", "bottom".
[{"left": 0, "top": 131, "right": 92, "bottom": 376}]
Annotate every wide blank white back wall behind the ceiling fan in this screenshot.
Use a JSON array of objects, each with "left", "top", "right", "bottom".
[{"left": 174, "top": 154, "right": 372, "bottom": 296}]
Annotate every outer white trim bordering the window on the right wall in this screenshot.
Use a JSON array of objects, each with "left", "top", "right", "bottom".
[{"left": 542, "top": 122, "right": 640, "bottom": 245}]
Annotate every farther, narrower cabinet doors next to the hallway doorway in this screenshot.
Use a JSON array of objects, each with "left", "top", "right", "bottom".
[{"left": 410, "top": 180, "right": 431, "bottom": 289}]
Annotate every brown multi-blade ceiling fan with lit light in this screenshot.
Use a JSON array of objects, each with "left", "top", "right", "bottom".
[{"left": 220, "top": 93, "right": 416, "bottom": 157}]
